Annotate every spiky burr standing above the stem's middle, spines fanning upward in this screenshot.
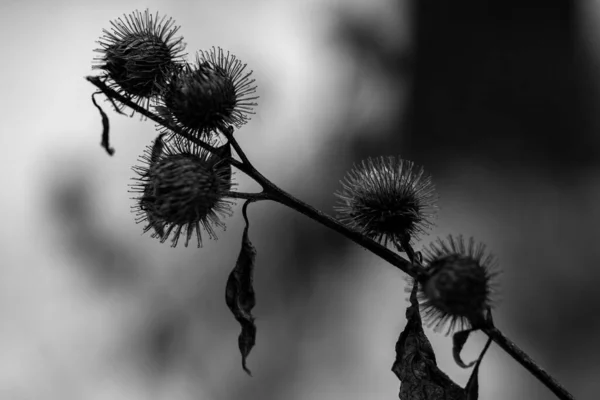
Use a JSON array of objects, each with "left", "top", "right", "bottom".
[{"left": 335, "top": 157, "right": 437, "bottom": 249}]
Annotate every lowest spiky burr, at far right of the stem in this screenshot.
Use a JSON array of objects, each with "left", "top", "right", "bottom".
[{"left": 419, "top": 236, "right": 499, "bottom": 334}]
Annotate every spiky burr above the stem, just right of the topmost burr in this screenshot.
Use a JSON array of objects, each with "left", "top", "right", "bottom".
[{"left": 157, "top": 48, "right": 258, "bottom": 137}]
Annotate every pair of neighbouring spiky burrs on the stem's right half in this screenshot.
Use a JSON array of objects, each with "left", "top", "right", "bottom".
[{"left": 336, "top": 157, "right": 499, "bottom": 333}]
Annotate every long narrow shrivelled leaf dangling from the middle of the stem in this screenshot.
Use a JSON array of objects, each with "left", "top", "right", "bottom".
[{"left": 225, "top": 201, "right": 256, "bottom": 376}]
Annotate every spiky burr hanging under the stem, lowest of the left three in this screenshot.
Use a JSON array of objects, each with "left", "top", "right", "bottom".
[{"left": 132, "top": 135, "right": 232, "bottom": 247}]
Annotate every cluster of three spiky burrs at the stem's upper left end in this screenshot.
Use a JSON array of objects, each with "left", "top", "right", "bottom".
[{"left": 94, "top": 10, "right": 258, "bottom": 247}]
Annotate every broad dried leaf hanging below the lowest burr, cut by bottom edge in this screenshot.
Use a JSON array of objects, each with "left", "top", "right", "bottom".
[{"left": 392, "top": 283, "right": 466, "bottom": 400}]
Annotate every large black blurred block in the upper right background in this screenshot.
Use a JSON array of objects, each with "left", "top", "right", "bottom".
[{"left": 405, "top": 0, "right": 599, "bottom": 175}]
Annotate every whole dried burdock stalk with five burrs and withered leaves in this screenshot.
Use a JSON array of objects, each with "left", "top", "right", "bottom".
[{"left": 87, "top": 11, "right": 573, "bottom": 400}]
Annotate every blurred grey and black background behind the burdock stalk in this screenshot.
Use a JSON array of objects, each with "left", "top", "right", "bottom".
[{"left": 0, "top": 0, "right": 600, "bottom": 400}]
